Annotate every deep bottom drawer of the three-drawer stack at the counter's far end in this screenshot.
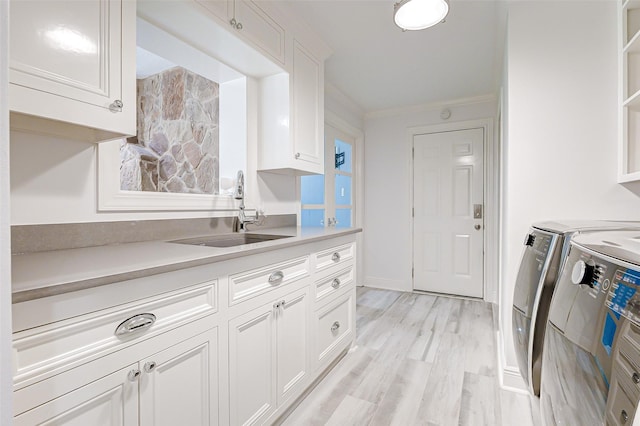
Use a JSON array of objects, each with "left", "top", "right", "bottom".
[{"left": 315, "top": 291, "right": 355, "bottom": 362}]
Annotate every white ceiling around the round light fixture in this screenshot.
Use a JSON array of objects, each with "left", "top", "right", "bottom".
[{"left": 278, "top": 0, "right": 506, "bottom": 112}]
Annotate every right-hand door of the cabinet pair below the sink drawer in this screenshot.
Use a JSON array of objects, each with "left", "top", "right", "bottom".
[{"left": 276, "top": 289, "right": 309, "bottom": 405}]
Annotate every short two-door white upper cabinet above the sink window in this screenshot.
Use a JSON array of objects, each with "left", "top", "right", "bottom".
[{"left": 196, "top": 0, "right": 285, "bottom": 65}]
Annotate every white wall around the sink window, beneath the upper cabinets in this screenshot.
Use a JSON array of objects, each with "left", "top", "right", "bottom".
[{"left": 11, "top": 79, "right": 299, "bottom": 225}]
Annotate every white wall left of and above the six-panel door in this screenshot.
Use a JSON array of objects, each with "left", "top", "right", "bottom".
[{"left": 362, "top": 98, "right": 496, "bottom": 291}]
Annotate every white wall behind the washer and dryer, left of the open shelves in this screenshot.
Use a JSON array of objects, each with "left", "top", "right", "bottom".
[{"left": 500, "top": 1, "right": 640, "bottom": 386}]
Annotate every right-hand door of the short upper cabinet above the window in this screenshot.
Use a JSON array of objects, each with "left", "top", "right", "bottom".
[{"left": 234, "top": 0, "right": 285, "bottom": 64}]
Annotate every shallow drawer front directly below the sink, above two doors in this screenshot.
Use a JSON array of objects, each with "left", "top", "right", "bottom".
[{"left": 229, "top": 256, "right": 309, "bottom": 305}]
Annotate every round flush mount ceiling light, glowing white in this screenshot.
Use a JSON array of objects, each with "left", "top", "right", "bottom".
[{"left": 393, "top": 0, "right": 449, "bottom": 31}]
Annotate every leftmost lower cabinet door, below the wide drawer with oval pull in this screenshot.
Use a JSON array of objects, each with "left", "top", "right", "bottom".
[{"left": 14, "top": 364, "right": 138, "bottom": 426}]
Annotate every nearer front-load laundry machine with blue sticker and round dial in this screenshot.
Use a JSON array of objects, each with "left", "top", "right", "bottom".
[{"left": 540, "top": 231, "right": 640, "bottom": 426}]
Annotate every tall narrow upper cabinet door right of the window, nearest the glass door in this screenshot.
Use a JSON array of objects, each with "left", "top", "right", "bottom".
[{"left": 291, "top": 41, "right": 324, "bottom": 174}]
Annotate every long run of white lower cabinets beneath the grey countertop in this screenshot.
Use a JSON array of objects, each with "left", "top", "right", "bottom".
[{"left": 13, "top": 236, "right": 356, "bottom": 426}]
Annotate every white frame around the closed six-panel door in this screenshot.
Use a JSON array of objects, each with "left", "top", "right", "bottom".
[{"left": 407, "top": 118, "right": 500, "bottom": 303}]
